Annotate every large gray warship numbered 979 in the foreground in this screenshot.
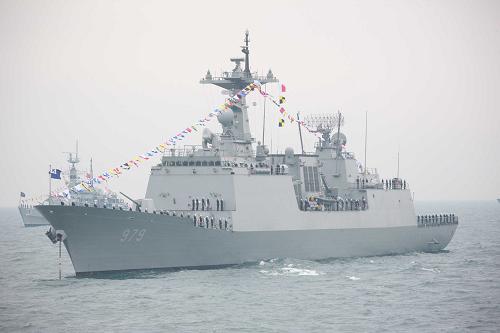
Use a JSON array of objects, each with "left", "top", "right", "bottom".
[{"left": 37, "top": 32, "right": 458, "bottom": 276}]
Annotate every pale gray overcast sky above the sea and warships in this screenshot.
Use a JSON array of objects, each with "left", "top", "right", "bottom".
[{"left": 0, "top": 0, "right": 500, "bottom": 206}]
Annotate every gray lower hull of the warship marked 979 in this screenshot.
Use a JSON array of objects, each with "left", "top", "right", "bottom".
[{"left": 37, "top": 206, "right": 457, "bottom": 275}]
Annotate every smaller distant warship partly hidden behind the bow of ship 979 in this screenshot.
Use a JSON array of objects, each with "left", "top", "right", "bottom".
[{"left": 18, "top": 144, "right": 128, "bottom": 227}]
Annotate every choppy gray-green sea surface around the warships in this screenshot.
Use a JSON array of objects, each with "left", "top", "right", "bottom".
[{"left": 0, "top": 201, "right": 500, "bottom": 332}]
